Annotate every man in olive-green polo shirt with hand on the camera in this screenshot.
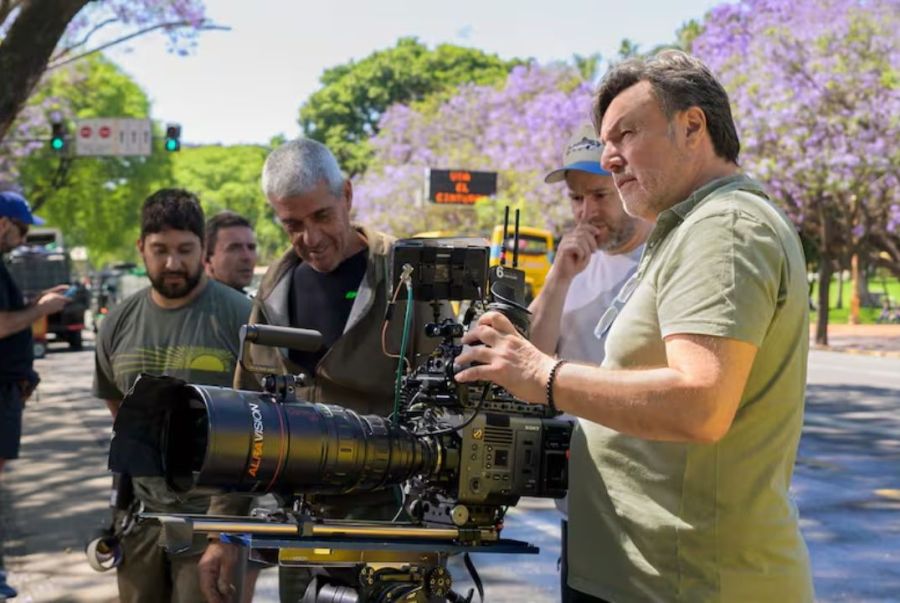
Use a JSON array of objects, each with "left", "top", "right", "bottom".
[{"left": 457, "top": 51, "right": 813, "bottom": 603}]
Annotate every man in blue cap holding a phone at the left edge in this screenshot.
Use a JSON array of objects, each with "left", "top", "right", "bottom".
[{"left": 0, "top": 191, "right": 69, "bottom": 599}]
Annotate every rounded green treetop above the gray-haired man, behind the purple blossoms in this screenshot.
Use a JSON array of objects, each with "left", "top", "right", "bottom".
[{"left": 300, "top": 38, "right": 522, "bottom": 175}]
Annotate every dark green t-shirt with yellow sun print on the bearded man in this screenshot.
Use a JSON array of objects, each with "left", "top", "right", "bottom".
[{"left": 93, "top": 280, "right": 251, "bottom": 512}]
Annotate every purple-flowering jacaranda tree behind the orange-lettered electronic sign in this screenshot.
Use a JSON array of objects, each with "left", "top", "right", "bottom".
[{"left": 354, "top": 64, "right": 591, "bottom": 236}]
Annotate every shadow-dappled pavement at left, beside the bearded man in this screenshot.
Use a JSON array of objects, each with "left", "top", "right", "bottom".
[{"left": 0, "top": 344, "right": 118, "bottom": 603}]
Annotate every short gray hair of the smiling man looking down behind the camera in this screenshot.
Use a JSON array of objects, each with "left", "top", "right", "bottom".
[{"left": 262, "top": 138, "right": 344, "bottom": 199}]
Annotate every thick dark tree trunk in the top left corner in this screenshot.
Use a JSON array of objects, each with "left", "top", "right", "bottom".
[{"left": 0, "top": 0, "right": 89, "bottom": 140}]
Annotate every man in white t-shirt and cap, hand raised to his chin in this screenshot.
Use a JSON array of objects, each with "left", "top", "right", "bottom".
[{"left": 529, "top": 124, "right": 652, "bottom": 602}]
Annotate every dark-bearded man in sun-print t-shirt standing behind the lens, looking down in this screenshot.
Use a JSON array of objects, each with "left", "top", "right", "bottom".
[{"left": 93, "top": 189, "right": 256, "bottom": 603}]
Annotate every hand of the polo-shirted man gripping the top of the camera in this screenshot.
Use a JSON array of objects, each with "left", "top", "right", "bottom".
[{"left": 456, "top": 312, "right": 555, "bottom": 404}]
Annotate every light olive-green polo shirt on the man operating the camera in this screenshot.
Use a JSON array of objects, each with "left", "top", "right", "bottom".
[{"left": 568, "top": 175, "right": 813, "bottom": 603}]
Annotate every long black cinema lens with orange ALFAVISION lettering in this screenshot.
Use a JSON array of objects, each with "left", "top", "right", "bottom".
[{"left": 161, "top": 385, "right": 440, "bottom": 495}]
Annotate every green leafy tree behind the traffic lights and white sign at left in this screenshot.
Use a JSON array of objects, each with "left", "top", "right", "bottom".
[{"left": 20, "top": 55, "right": 171, "bottom": 265}]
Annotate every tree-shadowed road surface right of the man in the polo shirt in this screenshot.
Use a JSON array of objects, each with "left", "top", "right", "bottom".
[{"left": 793, "top": 351, "right": 900, "bottom": 601}]
